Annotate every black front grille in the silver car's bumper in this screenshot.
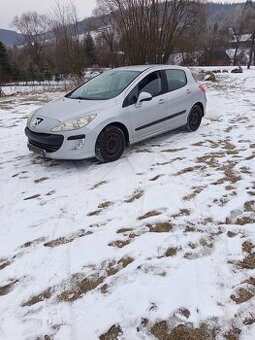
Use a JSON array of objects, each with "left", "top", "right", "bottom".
[{"left": 25, "top": 127, "right": 64, "bottom": 152}]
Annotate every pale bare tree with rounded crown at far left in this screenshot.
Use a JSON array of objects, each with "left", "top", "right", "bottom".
[{"left": 12, "top": 12, "right": 49, "bottom": 71}]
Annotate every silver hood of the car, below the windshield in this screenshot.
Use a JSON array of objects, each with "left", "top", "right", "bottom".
[{"left": 36, "top": 97, "right": 116, "bottom": 122}]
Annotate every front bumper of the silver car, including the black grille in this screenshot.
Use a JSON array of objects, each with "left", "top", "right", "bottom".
[{"left": 25, "top": 127, "right": 97, "bottom": 160}]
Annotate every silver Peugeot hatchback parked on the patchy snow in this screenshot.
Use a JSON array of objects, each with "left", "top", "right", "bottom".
[{"left": 25, "top": 65, "right": 206, "bottom": 162}]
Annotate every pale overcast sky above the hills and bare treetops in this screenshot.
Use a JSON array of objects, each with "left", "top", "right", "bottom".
[{"left": 0, "top": 0, "right": 246, "bottom": 29}]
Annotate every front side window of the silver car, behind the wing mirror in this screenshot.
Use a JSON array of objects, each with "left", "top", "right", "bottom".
[{"left": 122, "top": 71, "right": 163, "bottom": 107}]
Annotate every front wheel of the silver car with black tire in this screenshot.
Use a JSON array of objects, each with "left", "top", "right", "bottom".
[{"left": 95, "top": 125, "right": 125, "bottom": 162}]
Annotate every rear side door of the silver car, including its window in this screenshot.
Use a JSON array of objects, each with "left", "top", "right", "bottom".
[{"left": 165, "top": 69, "right": 192, "bottom": 130}]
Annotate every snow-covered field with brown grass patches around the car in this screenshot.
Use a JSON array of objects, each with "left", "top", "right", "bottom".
[{"left": 0, "top": 69, "right": 255, "bottom": 340}]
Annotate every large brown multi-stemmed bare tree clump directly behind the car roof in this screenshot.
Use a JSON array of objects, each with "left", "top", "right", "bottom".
[{"left": 94, "top": 0, "right": 202, "bottom": 64}]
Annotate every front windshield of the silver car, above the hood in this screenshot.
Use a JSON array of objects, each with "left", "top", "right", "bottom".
[{"left": 66, "top": 69, "right": 141, "bottom": 100}]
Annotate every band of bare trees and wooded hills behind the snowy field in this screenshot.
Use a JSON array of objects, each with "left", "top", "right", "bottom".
[{"left": 0, "top": 0, "right": 255, "bottom": 83}]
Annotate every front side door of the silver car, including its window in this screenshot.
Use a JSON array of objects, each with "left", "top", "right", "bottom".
[{"left": 123, "top": 71, "right": 167, "bottom": 141}]
